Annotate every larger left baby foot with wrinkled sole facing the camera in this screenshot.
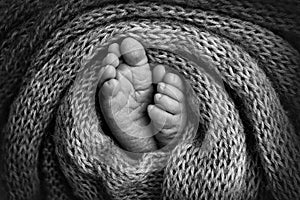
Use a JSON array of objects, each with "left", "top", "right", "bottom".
[{"left": 99, "top": 38, "right": 157, "bottom": 152}]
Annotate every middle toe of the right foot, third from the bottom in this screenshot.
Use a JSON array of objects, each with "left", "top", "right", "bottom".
[{"left": 157, "top": 82, "right": 184, "bottom": 102}]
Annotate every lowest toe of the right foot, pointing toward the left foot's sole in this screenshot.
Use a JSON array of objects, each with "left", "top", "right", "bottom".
[{"left": 147, "top": 105, "right": 178, "bottom": 129}]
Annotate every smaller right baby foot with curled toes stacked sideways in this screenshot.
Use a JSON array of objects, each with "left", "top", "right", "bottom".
[{"left": 148, "top": 65, "right": 187, "bottom": 147}]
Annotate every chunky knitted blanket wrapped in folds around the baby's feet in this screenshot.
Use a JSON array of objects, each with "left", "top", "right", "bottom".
[{"left": 0, "top": 0, "right": 300, "bottom": 200}]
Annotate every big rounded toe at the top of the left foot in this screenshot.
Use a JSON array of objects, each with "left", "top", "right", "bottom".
[{"left": 120, "top": 38, "right": 148, "bottom": 66}]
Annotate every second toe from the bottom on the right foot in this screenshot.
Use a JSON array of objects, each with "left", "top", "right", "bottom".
[{"left": 154, "top": 93, "right": 183, "bottom": 114}]
